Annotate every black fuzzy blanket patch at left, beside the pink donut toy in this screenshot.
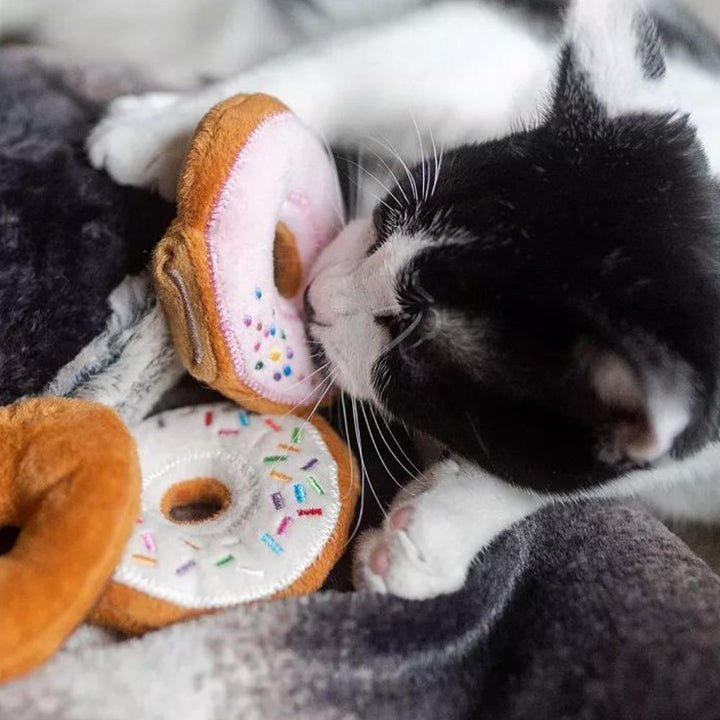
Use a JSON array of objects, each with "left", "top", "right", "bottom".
[{"left": 0, "top": 51, "right": 171, "bottom": 404}]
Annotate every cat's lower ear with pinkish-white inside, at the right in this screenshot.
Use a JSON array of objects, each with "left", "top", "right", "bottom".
[{"left": 577, "top": 341, "right": 696, "bottom": 465}]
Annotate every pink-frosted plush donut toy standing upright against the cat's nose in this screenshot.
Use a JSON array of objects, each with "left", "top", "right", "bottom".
[{"left": 154, "top": 95, "right": 342, "bottom": 412}]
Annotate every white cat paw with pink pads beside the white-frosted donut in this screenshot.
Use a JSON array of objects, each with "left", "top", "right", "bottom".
[{"left": 354, "top": 486, "right": 472, "bottom": 600}]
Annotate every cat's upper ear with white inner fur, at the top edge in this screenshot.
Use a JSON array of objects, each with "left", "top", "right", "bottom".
[{"left": 553, "top": 0, "right": 678, "bottom": 119}]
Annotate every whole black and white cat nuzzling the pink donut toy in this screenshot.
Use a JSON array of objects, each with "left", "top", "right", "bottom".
[{"left": 81, "top": 0, "right": 720, "bottom": 598}]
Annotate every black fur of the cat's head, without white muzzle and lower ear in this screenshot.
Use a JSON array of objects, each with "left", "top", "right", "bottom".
[{"left": 366, "top": 32, "right": 720, "bottom": 491}]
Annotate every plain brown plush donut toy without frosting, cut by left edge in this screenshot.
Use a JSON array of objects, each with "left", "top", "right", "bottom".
[{"left": 0, "top": 398, "right": 140, "bottom": 681}]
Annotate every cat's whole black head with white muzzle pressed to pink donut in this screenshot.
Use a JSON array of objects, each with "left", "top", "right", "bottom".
[{"left": 306, "top": 0, "right": 720, "bottom": 491}]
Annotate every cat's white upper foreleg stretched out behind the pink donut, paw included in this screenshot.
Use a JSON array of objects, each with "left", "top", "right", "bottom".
[{"left": 88, "top": 2, "right": 554, "bottom": 198}]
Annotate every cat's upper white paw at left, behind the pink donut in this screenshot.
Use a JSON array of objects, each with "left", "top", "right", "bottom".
[{"left": 87, "top": 93, "right": 198, "bottom": 200}]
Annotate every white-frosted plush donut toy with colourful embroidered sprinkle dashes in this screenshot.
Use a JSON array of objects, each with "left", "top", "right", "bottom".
[{"left": 92, "top": 403, "right": 357, "bottom": 632}]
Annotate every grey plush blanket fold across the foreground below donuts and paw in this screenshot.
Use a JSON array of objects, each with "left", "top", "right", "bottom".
[{"left": 0, "top": 504, "right": 720, "bottom": 720}]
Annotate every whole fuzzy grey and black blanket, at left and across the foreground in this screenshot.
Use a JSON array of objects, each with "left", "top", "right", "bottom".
[{"left": 0, "top": 52, "right": 720, "bottom": 720}]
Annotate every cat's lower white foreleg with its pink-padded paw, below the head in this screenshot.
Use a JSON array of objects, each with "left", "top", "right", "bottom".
[{"left": 354, "top": 460, "right": 548, "bottom": 599}]
